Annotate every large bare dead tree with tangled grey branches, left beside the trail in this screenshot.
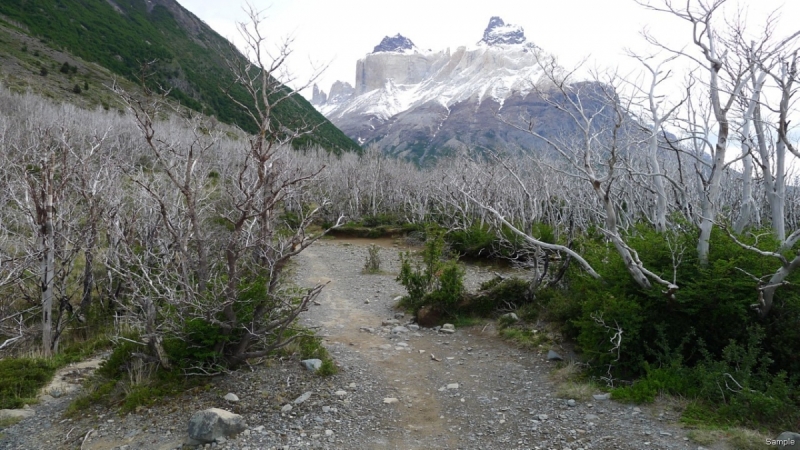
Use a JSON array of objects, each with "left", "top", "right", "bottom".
[{"left": 113, "top": 9, "right": 342, "bottom": 373}]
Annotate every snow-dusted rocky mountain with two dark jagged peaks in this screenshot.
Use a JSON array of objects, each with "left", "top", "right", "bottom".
[{"left": 312, "top": 17, "right": 600, "bottom": 163}]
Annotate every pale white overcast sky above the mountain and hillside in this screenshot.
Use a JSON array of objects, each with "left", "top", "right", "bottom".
[{"left": 178, "top": 0, "right": 800, "bottom": 97}]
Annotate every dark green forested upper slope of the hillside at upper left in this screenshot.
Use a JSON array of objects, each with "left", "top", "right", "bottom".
[{"left": 0, "top": 0, "right": 358, "bottom": 152}]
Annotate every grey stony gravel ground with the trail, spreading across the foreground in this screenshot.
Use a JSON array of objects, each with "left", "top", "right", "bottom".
[{"left": 0, "top": 237, "right": 724, "bottom": 450}]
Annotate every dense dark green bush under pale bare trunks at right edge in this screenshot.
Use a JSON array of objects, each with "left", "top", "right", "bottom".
[{"left": 555, "top": 227, "right": 800, "bottom": 429}]
